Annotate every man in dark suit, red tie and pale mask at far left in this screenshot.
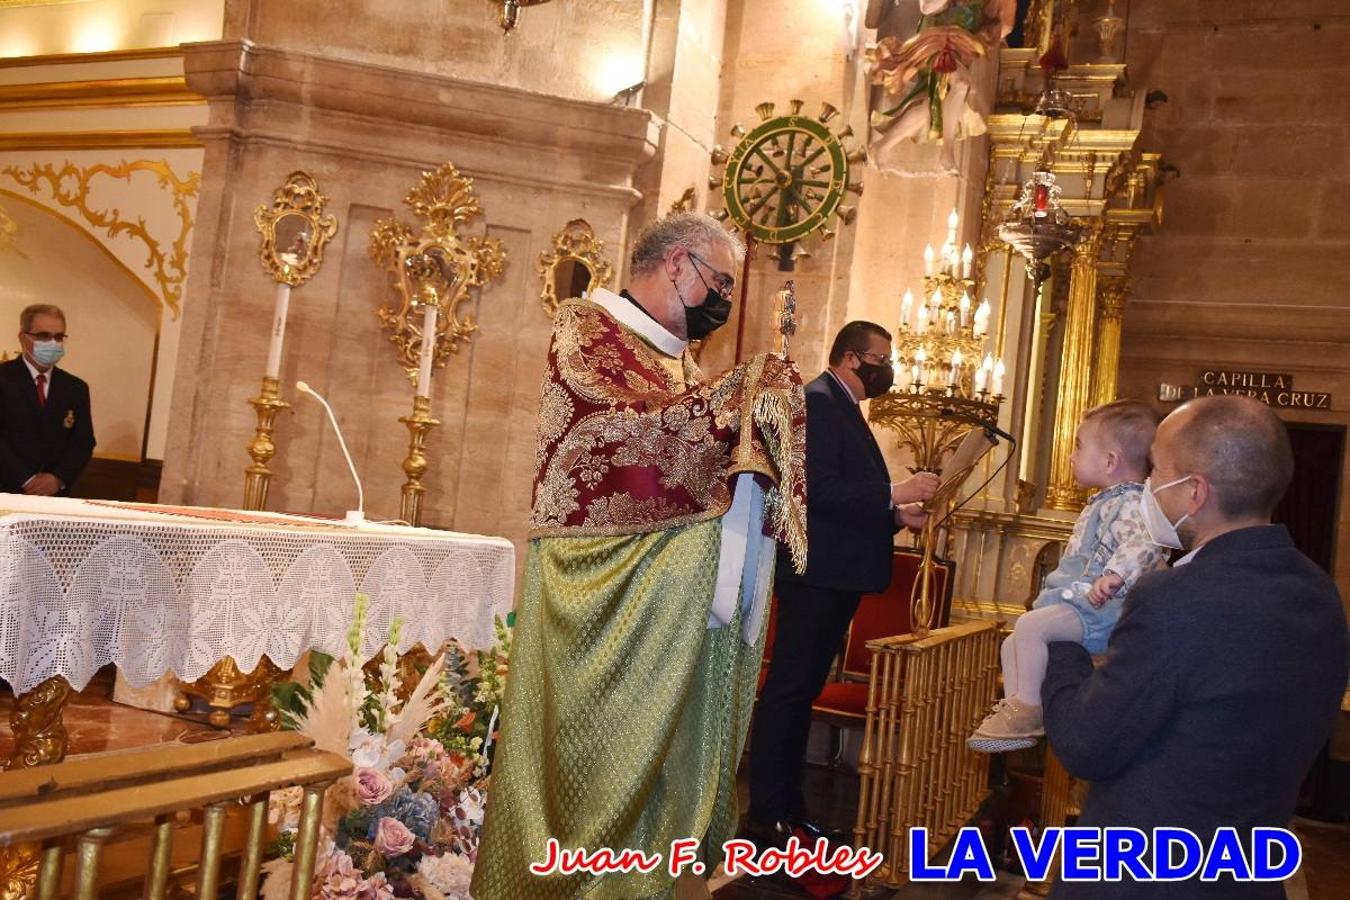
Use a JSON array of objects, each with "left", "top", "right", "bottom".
[{"left": 0, "top": 304, "right": 95, "bottom": 497}]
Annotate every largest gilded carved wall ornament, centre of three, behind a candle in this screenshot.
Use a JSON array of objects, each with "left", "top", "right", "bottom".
[{"left": 370, "top": 162, "right": 506, "bottom": 381}]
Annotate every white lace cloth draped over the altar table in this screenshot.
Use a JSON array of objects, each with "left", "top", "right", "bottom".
[{"left": 0, "top": 494, "right": 516, "bottom": 694}]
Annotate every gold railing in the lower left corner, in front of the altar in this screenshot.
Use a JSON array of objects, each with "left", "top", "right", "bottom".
[{"left": 0, "top": 734, "right": 351, "bottom": 900}]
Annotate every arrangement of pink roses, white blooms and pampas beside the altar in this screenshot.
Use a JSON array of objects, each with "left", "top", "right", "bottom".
[{"left": 262, "top": 595, "right": 510, "bottom": 900}]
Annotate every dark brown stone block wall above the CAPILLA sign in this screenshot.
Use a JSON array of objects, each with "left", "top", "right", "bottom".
[{"left": 1121, "top": 0, "right": 1350, "bottom": 596}]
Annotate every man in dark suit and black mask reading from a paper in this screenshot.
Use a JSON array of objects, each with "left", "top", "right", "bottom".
[{"left": 745, "top": 321, "right": 938, "bottom": 843}]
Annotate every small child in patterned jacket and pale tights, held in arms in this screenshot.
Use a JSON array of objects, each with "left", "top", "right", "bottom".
[{"left": 967, "top": 399, "right": 1168, "bottom": 753}]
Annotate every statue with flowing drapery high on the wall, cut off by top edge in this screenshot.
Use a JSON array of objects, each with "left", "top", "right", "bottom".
[{"left": 868, "top": 0, "right": 1017, "bottom": 171}]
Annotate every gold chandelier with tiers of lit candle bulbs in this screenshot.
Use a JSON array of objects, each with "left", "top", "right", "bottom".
[{"left": 869, "top": 203, "right": 1004, "bottom": 471}]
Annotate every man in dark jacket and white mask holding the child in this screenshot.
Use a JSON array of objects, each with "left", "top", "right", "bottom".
[{"left": 1041, "top": 397, "right": 1350, "bottom": 900}]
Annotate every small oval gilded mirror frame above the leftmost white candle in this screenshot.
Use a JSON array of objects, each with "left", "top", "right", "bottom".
[{"left": 254, "top": 171, "right": 338, "bottom": 287}]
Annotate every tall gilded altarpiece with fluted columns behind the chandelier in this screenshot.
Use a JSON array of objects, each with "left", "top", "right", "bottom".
[{"left": 948, "top": 26, "right": 1164, "bottom": 615}]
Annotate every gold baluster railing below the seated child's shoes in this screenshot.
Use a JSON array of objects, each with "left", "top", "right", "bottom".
[{"left": 853, "top": 621, "right": 999, "bottom": 887}]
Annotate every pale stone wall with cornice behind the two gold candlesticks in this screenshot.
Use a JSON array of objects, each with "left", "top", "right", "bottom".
[{"left": 162, "top": 42, "right": 656, "bottom": 555}]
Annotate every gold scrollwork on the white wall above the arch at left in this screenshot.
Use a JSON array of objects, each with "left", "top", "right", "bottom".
[{"left": 0, "top": 159, "right": 201, "bottom": 318}]
